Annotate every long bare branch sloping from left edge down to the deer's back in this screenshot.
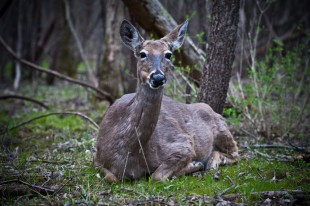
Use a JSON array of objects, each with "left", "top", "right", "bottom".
[{"left": 0, "top": 36, "right": 114, "bottom": 104}]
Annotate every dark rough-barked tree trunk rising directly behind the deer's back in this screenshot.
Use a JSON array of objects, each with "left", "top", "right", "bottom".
[{"left": 198, "top": 0, "right": 240, "bottom": 114}]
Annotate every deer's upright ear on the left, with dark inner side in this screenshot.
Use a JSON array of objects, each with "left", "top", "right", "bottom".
[{"left": 120, "top": 20, "right": 144, "bottom": 53}]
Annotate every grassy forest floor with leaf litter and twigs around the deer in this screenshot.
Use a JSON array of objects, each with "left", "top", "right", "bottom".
[{"left": 0, "top": 83, "right": 310, "bottom": 206}]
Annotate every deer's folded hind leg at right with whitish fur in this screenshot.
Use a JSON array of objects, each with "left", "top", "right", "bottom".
[{"left": 206, "top": 123, "right": 240, "bottom": 169}]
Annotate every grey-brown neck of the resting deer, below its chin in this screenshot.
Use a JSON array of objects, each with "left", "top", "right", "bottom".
[{"left": 131, "top": 84, "right": 163, "bottom": 148}]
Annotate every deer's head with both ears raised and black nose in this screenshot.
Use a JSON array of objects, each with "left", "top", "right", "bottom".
[{"left": 120, "top": 20, "right": 188, "bottom": 89}]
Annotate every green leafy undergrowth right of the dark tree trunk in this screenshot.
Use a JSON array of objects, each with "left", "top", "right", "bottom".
[{"left": 228, "top": 41, "right": 310, "bottom": 140}]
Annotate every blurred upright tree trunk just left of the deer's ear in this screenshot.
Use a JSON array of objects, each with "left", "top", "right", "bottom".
[{"left": 98, "top": 0, "right": 124, "bottom": 98}]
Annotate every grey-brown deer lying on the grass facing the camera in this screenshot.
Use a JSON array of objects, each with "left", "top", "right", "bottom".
[{"left": 94, "top": 20, "right": 239, "bottom": 183}]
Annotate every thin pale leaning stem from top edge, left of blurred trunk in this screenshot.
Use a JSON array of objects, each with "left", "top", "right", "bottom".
[{"left": 63, "top": 0, "right": 98, "bottom": 87}]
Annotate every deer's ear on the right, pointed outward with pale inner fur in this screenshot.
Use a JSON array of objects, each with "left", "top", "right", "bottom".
[{"left": 161, "top": 20, "right": 188, "bottom": 51}]
